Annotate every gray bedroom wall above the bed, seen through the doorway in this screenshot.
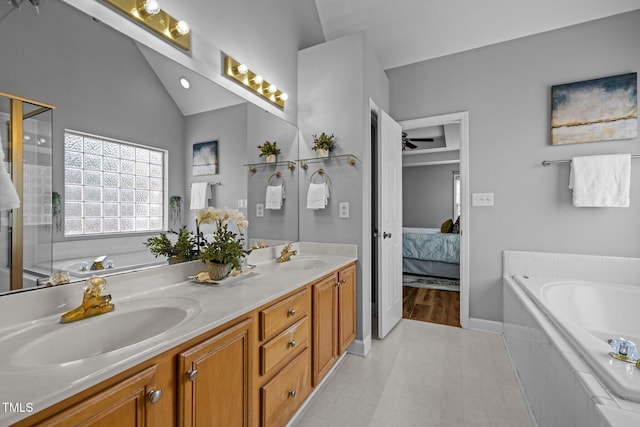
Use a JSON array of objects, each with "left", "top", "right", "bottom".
[{"left": 402, "top": 164, "right": 460, "bottom": 228}]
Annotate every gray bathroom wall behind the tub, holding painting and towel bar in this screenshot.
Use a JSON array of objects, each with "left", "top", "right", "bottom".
[{"left": 387, "top": 11, "right": 640, "bottom": 321}]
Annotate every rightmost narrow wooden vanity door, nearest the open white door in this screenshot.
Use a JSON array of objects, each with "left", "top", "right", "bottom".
[{"left": 338, "top": 265, "right": 356, "bottom": 354}]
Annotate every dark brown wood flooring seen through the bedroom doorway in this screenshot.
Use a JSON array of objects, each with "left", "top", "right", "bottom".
[{"left": 402, "top": 286, "right": 460, "bottom": 327}]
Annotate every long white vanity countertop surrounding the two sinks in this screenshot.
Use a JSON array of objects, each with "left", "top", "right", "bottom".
[{"left": 0, "top": 243, "right": 357, "bottom": 425}]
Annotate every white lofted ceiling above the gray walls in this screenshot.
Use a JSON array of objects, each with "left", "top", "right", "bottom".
[{"left": 315, "top": 0, "right": 640, "bottom": 70}]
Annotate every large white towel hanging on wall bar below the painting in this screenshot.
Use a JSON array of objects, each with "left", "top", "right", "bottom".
[{"left": 569, "top": 154, "right": 631, "bottom": 208}]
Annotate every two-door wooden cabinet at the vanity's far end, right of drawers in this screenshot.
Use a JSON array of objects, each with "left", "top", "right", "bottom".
[{"left": 312, "top": 264, "right": 356, "bottom": 386}]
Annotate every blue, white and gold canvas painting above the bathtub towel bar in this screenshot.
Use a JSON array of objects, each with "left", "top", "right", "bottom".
[{"left": 551, "top": 73, "right": 638, "bottom": 145}]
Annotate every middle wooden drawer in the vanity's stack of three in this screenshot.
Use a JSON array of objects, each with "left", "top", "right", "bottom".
[{"left": 260, "top": 316, "right": 309, "bottom": 375}]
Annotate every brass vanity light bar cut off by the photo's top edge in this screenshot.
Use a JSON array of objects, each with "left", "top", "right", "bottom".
[{"left": 103, "top": 0, "right": 191, "bottom": 50}]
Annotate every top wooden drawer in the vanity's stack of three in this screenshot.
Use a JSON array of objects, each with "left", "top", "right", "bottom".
[{"left": 260, "top": 288, "right": 309, "bottom": 341}]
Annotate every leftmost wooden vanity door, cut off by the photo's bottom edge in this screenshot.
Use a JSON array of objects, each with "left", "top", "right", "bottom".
[{"left": 36, "top": 366, "right": 161, "bottom": 427}]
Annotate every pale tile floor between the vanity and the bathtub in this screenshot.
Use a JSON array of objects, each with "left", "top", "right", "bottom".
[{"left": 293, "top": 319, "right": 532, "bottom": 427}]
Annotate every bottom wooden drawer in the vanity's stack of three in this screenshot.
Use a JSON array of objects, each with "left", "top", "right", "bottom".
[{"left": 260, "top": 349, "right": 311, "bottom": 427}]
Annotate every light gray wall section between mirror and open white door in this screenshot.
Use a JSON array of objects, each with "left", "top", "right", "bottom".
[{"left": 298, "top": 33, "right": 389, "bottom": 352}]
